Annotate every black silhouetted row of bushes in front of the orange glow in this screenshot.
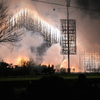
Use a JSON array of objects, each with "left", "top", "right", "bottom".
[{"left": 0, "top": 62, "right": 55, "bottom": 76}]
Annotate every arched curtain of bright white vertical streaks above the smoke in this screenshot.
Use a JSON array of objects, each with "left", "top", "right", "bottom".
[{"left": 8, "top": 9, "right": 61, "bottom": 47}]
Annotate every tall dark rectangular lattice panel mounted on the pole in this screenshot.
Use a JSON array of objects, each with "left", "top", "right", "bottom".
[{"left": 61, "top": 19, "right": 76, "bottom": 55}]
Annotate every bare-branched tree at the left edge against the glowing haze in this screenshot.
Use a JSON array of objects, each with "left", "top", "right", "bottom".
[{"left": 0, "top": 0, "right": 23, "bottom": 44}]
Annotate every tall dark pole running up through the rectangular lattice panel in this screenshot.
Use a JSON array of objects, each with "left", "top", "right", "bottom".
[{"left": 65, "top": 0, "right": 70, "bottom": 73}]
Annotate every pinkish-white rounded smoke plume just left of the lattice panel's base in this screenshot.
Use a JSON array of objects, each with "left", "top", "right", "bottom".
[{"left": 43, "top": 43, "right": 63, "bottom": 67}]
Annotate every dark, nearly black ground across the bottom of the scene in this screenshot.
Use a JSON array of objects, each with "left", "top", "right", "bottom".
[{"left": 0, "top": 74, "right": 100, "bottom": 100}]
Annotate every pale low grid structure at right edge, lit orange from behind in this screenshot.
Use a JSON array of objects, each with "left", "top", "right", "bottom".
[{"left": 80, "top": 52, "right": 100, "bottom": 72}]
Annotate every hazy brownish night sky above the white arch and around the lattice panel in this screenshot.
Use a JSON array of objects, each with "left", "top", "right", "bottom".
[{"left": 1, "top": 0, "right": 100, "bottom": 72}]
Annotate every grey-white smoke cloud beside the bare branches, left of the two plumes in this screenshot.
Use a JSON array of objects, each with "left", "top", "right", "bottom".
[{"left": 0, "top": 27, "right": 44, "bottom": 64}]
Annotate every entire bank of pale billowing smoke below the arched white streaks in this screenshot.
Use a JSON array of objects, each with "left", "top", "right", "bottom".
[{"left": 0, "top": 29, "right": 63, "bottom": 67}]
